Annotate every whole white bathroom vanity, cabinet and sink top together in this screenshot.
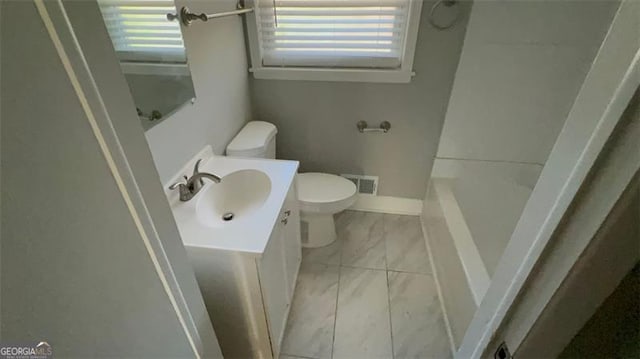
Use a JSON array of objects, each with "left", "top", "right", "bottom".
[{"left": 165, "top": 148, "right": 301, "bottom": 358}]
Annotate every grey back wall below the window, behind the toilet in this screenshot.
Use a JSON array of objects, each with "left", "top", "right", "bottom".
[{"left": 251, "top": 1, "right": 470, "bottom": 198}]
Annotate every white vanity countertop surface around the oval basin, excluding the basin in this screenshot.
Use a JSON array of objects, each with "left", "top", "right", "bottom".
[{"left": 164, "top": 147, "right": 299, "bottom": 256}]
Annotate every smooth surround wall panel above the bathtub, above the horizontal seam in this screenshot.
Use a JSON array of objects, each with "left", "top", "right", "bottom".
[{"left": 438, "top": 0, "right": 618, "bottom": 165}]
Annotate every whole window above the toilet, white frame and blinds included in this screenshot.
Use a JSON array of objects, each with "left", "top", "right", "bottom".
[{"left": 247, "top": 0, "right": 422, "bottom": 82}]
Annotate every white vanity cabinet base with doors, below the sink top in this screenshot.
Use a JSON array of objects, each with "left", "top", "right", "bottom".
[{"left": 186, "top": 181, "right": 302, "bottom": 358}]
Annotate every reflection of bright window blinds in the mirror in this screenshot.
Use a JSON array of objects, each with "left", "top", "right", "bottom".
[{"left": 98, "top": 0, "right": 186, "bottom": 62}]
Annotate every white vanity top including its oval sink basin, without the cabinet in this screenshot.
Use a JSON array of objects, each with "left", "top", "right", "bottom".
[{"left": 166, "top": 149, "right": 298, "bottom": 256}]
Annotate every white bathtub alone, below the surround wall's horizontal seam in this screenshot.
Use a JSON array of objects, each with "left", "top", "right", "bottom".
[{"left": 423, "top": 174, "right": 532, "bottom": 348}]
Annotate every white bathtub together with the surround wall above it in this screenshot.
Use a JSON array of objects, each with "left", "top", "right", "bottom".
[{"left": 422, "top": 0, "right": 619, "bottom": 347}]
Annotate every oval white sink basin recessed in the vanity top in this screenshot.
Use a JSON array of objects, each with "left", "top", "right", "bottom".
[{"left": 196, "top": 169, "right": 271, "bottom": 227}]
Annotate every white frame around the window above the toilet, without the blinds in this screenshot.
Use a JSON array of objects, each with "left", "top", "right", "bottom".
[{"left": 246, "top": 0, "right": 422, "bottom": 83}]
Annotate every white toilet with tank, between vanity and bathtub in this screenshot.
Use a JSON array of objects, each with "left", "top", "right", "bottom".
[{"left": 227, "top": 121, "right": 356, "bottom": 247}]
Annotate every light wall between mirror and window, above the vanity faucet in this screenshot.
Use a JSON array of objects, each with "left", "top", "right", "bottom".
[{"left": 146, "top": 0, "right": 251, "bottom": 182}]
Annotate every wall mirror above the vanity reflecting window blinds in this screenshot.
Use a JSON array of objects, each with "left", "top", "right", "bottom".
[{"left": 98, "top": 0, "right": 195, "bottom": 131}]
